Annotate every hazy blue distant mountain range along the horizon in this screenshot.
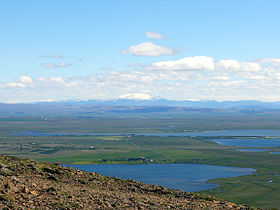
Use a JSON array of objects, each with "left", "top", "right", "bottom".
[{"left": 0, "top": 99, "right": 280, "bottom": 118}]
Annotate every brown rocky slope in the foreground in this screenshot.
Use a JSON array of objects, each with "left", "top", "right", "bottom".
[{"left": 0, "top": 156, "right": 255, "bottom": 209}]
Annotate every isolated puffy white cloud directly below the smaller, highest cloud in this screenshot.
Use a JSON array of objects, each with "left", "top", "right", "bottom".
[{"left": 122, "top": 42, "right": 175, "bottom": 56}]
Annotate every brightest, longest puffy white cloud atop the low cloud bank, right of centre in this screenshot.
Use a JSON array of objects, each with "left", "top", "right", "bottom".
[{"left": 147, "top": 56, "right": 215, "bottom": 71}]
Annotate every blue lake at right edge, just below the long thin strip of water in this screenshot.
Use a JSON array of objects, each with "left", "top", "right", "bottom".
[{"left": 209, "top": 139, "right": 280, "bottom": 147}]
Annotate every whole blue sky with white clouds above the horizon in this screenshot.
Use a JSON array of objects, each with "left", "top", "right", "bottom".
[{"left": 0, "top": 0, "right": 280, "bottom": 103}]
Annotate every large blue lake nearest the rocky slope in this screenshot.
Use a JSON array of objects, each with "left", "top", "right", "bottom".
[{"left": 64, "top": 164, "right": 255, "bottom": 192}]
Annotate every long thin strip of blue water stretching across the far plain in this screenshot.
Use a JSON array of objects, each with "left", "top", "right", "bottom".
[{"left": 12, "top": 130, "right": 280, "bottom": 137}]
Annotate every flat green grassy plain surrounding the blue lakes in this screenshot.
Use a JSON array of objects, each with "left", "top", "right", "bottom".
[{"left": 0, "top": 116, "right": 280, "bottom": 208}]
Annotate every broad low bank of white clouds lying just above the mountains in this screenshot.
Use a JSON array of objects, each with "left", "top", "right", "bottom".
[{"left": 0, "top": 56, "right": 280, "bottom": 102}]
